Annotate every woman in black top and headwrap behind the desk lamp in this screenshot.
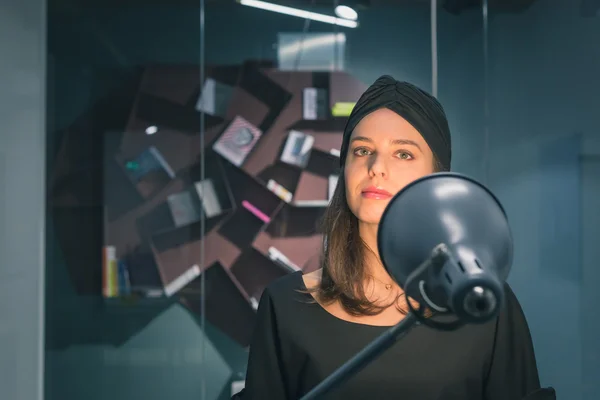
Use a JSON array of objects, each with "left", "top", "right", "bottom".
[{"left": 233, "top": 76, "right": 539, "bottom": 400}]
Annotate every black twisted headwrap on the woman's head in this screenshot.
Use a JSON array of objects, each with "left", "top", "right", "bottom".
[{"left": 340, "top": 75, "right": 452, "bottom": 171}]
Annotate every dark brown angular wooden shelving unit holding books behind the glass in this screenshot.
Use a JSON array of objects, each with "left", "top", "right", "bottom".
[{"left": 49, "top": 62, "right": 365, "bottom": 347}]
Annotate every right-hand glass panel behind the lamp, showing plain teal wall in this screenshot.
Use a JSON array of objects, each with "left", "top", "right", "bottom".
[{"left": 438, "top": 0, "right": 600, "bottom": 399}]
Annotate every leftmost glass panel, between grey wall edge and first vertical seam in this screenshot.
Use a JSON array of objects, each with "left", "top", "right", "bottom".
[{"left": 45, "top": 1, "right": 214, "bottom": 400}]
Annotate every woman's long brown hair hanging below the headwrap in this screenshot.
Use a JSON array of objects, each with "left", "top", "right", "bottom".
[{"left": 308, "top": 156, "right": 443, "bottom": 316}]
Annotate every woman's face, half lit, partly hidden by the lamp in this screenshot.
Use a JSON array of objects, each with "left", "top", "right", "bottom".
[{"left": 344, "top": 108, "right": 434, "bottom": 225}]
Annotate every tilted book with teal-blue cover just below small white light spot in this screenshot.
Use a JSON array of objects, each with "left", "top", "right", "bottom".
[{"left": 123, "top": 146, "right": 175, "bottom": 197}]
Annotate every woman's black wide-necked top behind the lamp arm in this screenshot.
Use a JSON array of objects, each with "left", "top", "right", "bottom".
[{"left": 234, "top": 272, "right": 540, "bottom": 400}]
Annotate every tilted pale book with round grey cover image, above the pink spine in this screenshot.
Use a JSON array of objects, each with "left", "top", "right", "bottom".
[{"left": 213, "top": 115, "right": 262, "bottom": 167}]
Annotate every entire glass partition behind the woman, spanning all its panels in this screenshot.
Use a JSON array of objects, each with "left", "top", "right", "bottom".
[{"left": 45, "top": 0, "right": 600, "bottom": 400}]
